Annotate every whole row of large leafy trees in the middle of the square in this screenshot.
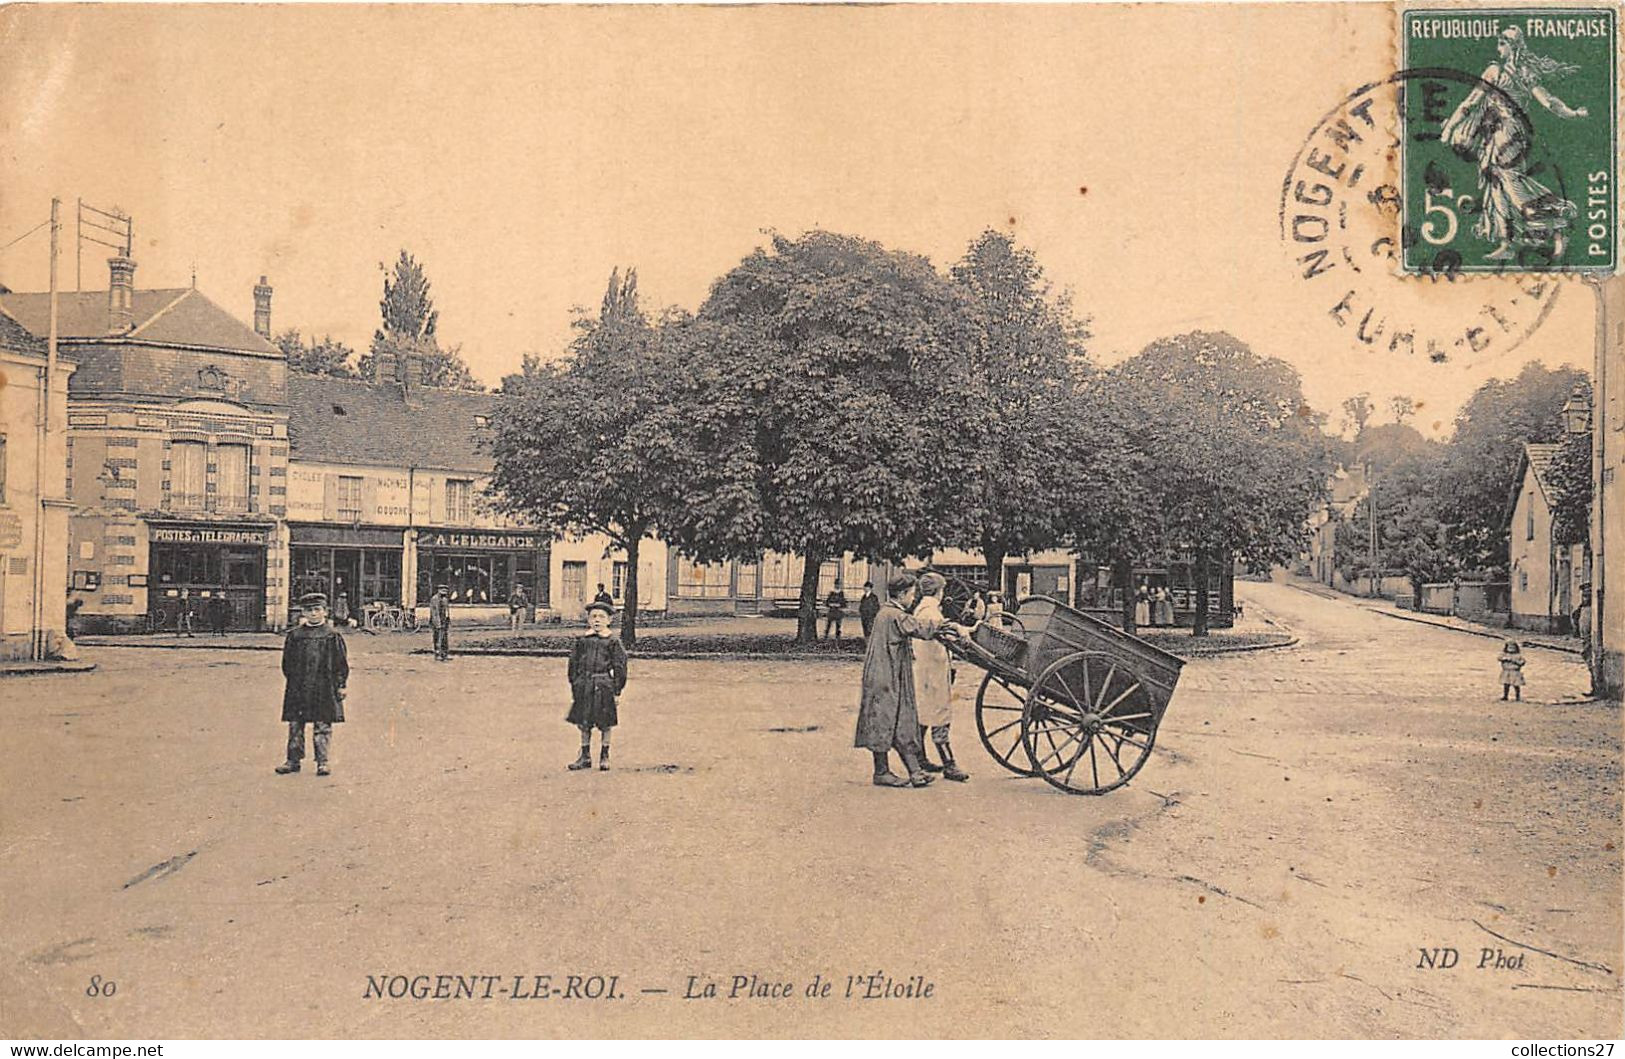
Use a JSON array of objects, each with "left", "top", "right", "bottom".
[{"left": 491, "top": 231, "right": 1331, "bottom": 643}]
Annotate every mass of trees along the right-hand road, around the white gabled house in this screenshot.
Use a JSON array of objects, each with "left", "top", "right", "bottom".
[{"left": 1336, "top": 362, "right": 1591, "bottom": 603}]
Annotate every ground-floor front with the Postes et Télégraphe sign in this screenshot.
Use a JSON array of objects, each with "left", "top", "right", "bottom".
[{"left": 146, "top": 523, "right": 271, "bottom": 632}]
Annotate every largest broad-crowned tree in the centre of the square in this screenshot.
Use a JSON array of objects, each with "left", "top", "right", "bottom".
[{"left": 674, "top": 231, "right": 975, "bottom": 640}]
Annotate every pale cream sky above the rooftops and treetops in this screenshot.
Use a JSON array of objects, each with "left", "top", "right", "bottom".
[{"left": 0, "top": 5, "right": 1593, "bottom": 430}]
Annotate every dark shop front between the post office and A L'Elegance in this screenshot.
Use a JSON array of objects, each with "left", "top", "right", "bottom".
[{"left": 288, "top": 523, "right": 405, "bottom": 620}]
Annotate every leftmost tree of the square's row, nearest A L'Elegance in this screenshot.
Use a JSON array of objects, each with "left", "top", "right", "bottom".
[{"left": 489, "top": 273, "right": 684, "bottom": 646}]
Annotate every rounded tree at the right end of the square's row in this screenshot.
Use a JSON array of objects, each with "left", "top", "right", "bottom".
[{"left": 1118, "top": 331, "right": 1331, "bottom": 635}]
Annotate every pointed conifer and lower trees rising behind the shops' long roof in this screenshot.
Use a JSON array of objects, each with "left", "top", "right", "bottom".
[{"left": 273, "top": 250, "right": 484, "bottom": 390}]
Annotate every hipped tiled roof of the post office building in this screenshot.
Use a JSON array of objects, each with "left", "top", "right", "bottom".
[{"left": 0, "top": 287, "right": 278, "bottom": 352}]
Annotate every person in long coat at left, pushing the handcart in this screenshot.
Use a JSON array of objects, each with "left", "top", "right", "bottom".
[{"left": 853, "top": 573, "right": 931, "bottom": 786}]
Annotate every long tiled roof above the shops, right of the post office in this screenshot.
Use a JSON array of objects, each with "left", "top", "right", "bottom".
[{"left": 288, "top": 372, "right": 501, "bottom": 473}]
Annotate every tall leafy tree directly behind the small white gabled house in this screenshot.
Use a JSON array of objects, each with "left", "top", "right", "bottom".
[{"left": 1438, "top": 362, "right": 1586, "bottom": 572}]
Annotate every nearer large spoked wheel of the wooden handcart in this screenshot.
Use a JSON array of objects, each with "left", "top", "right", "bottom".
[{"left": 1022, "top": 651, "right": 1157, "bottom": 794}]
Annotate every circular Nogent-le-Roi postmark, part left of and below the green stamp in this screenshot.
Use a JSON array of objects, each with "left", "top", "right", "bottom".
[{"left": 1279, "top": 70, "right": 1562, "bottom": 364}]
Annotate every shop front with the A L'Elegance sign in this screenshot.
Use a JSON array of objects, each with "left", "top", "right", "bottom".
[{"left": 418, "top": 530, "right": 549, "bottom": 609}]
